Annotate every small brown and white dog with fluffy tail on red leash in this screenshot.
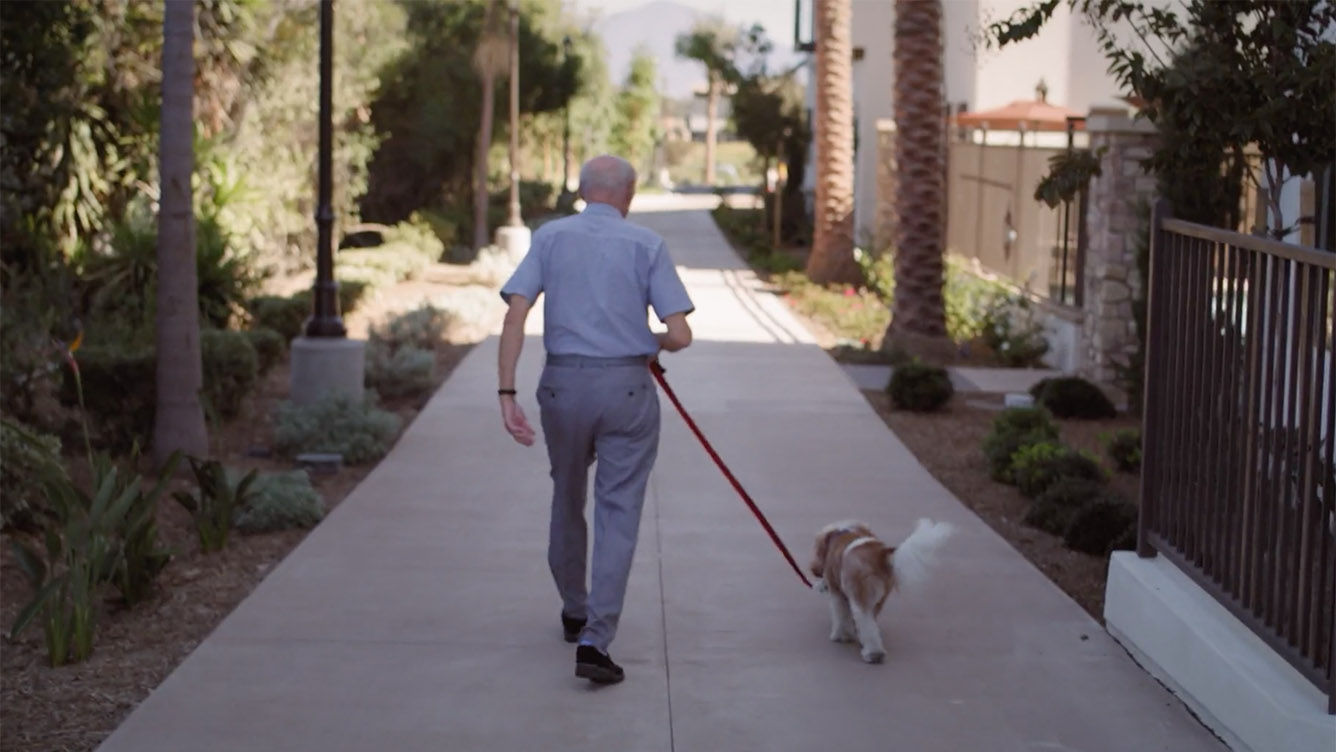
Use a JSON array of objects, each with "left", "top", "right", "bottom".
[{"left": 811, "top": 518, "right": 954, "bottom": 664}]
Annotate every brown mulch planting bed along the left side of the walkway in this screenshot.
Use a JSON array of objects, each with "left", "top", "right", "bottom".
[{"left": 0, "top": 289, "right": 473, "bottom": 752}]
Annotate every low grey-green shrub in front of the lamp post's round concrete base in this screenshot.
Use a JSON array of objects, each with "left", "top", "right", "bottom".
[{"left": 274, "top": 394, "right": 399, "bottom": 465}]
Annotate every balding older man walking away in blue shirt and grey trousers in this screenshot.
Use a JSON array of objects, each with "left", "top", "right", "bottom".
[{"left": 497, "top": 155, "right": 693, "bottom": 684}]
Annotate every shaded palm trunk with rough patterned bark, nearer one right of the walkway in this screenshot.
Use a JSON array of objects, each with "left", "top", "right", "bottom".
[{"left": 886, "top": 0, "right": 950, "bottom": 357}]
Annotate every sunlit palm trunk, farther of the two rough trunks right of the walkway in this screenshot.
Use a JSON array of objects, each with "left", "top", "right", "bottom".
[{"left": 807, "top": 0, "right": 862, "bottom": 283}]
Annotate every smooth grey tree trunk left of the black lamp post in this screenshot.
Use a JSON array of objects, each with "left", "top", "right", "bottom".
[{"left": 154, "top": 3, "right": 208, "bottom": 465}]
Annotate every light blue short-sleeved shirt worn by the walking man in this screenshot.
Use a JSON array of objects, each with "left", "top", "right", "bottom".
[{"left": 501, "top": 203, "right": 695, "bottom": 358}]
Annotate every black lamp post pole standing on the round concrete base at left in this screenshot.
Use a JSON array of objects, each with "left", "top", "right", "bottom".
[{"left": 306, "top": 0, "right": 347, "bottom": 337}]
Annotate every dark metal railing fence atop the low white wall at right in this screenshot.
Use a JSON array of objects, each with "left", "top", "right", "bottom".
[{"left": 1137, "top": 203, "right": 1336, "bottom": 712}]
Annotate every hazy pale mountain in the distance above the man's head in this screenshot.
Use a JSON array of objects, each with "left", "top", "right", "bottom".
[{"left": 593, "top": 0, "right": 705, "bottom": 99}]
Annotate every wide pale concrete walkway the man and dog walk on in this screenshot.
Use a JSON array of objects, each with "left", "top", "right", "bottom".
[{"left": 102, "top": 198, "right": 1222, "bottom": 752}]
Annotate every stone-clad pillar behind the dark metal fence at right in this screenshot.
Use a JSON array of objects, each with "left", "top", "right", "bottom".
[{"left": 1078, "top": 108, "right": 1156, "bottom": 387}]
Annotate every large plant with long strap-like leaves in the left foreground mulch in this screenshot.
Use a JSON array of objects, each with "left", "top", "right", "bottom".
[{"left": 11, "top": 462, "right": 140, "bottom": 667}]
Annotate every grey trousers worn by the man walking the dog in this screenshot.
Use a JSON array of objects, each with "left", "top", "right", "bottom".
[{"left": 538, "top": 357, "right": 659, "bottom": 652}]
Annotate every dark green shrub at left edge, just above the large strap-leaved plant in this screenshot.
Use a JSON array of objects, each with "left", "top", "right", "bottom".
[{"left": 0, "top": 418, "right": 69, "bottom": 530}]
